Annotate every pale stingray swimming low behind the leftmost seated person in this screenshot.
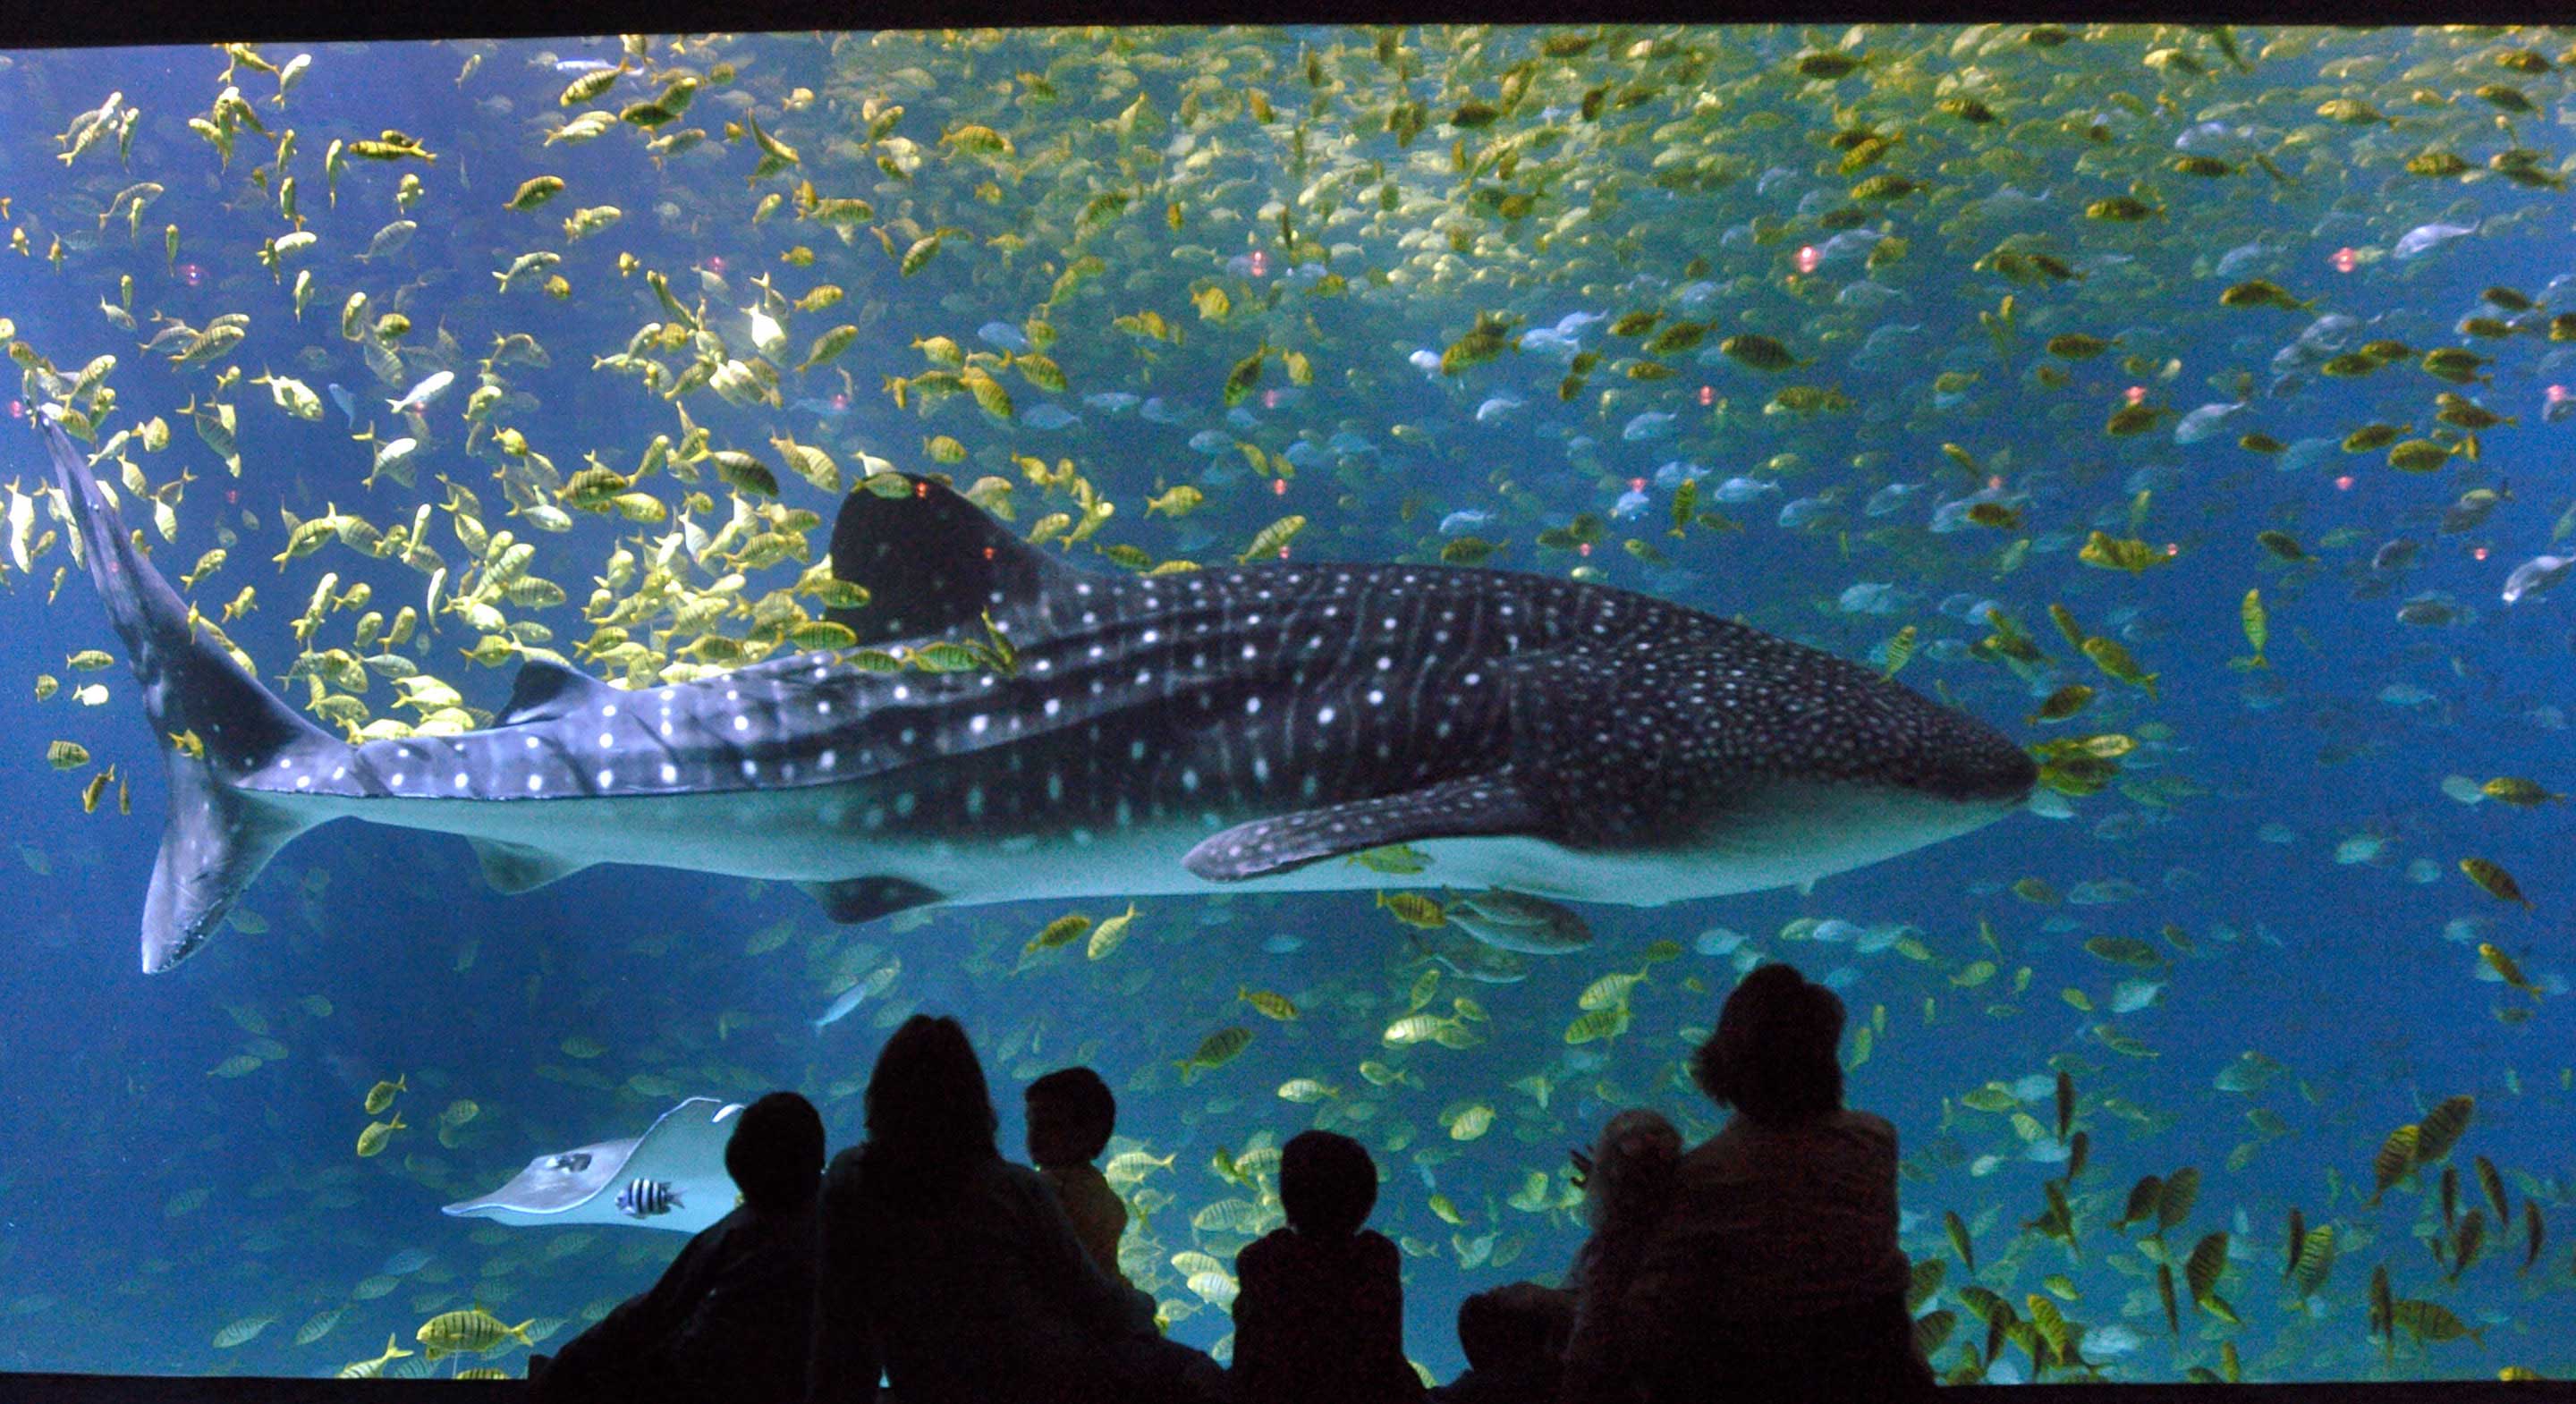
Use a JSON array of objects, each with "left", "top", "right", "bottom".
[{"left": 440, "top": 1097, "right": 741, "bottom": 1234}]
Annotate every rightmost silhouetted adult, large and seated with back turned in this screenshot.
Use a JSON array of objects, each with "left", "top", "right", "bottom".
[{"left": 1623, "top": 963, "right": 1932, "bottom": 1404}]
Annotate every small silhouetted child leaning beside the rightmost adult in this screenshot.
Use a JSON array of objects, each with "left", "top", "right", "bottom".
[{"left": 1558, "top": 1108, "right": 1682, "bottom": 1404}]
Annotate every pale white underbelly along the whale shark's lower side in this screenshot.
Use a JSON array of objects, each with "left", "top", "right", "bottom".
[{"left": 278, "top": 767, "right": 2012, "bottom": 907}]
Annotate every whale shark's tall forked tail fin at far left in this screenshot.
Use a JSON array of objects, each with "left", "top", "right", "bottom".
[{"left": 36, "top": 412, "right": 332, "bottom": 974}]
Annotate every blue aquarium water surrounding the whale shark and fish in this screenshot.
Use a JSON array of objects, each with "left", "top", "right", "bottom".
[{"left": 0, "top": 26, "right": 2576, "bottom": 1381}]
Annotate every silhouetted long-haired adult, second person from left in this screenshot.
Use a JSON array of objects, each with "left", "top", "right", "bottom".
[{"left": 806, "top": 1015, "right": 1224, "bottom": 1404}]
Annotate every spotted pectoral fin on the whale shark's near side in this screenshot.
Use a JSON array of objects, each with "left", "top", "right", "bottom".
[{"left": 1180, "top": 767, "right": 1548, "bottom": 884}]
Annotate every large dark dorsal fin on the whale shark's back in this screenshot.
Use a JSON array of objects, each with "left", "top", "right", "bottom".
[{"left": 825, "top": 474, "right": 1082, "bottom": 644}]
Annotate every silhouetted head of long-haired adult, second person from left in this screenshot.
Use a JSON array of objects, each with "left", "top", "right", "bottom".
[{"left": 860, "top": 1015, "right": 1002, "bottom": 1200}]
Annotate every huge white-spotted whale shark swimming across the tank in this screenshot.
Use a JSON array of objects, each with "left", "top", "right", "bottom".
[{"left": 33, "top": 415, "right": 2035, "bottom": 971}]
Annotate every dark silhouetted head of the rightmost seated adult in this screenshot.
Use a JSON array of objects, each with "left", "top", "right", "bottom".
[{"left": 1690, "top": 966, "right": 1842, "bottom": 1126}]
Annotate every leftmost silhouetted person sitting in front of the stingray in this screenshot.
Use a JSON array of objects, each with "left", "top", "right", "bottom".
[{"left": 528, "top": 1092, "right": 825, "bottom": 1404}]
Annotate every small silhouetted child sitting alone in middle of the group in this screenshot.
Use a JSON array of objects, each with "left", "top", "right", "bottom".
[{"left": 1234, "top": 1131, "right": 1422, "bottom": 1404}]
